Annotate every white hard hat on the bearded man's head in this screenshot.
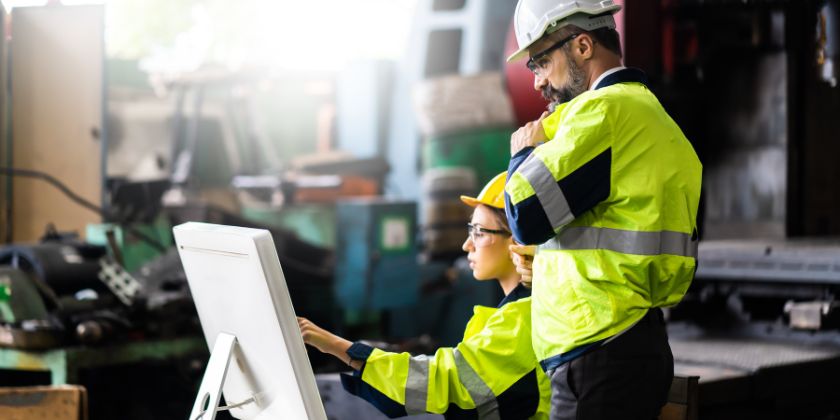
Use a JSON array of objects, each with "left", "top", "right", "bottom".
[{"left": 507, "top": 0, "right": 621, "bottom": 62}]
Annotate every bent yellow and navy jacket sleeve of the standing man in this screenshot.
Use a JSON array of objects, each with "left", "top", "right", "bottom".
[{"left": 505, "top": 100, "right": 612, "bottom": 245}]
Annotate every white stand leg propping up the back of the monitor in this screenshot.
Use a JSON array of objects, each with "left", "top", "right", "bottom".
[{"left": 189, "top": 333, "right": 255, "bottom": 420}]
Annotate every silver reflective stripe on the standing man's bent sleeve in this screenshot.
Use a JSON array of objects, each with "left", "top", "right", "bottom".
[{"left": 517, "top": 153, "right": 575, "bottom": 232}]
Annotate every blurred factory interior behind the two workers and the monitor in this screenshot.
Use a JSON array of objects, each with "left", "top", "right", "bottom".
[{"left": 0, "top": 0, "right": 840, "bottom": 420}]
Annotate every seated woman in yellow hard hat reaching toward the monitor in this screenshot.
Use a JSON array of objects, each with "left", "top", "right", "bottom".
[{"left": 298, "top": 173, "right": 551, "bottom": 419}]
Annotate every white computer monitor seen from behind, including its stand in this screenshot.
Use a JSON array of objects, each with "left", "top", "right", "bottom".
[{"left": 174, "top": 222, "right": 327, "bottom": 420}]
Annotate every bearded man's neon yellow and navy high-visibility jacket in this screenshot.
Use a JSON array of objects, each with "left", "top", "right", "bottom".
[{"left": 505, "top": 69, "right": 702, "bottom": 369}]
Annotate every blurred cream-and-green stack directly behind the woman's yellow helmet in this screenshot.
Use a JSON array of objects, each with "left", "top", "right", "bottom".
[{"left": 414, "top": 72, "right": 515, "bottom": 259}]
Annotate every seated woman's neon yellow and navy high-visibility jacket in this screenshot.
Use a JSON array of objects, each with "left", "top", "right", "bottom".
[{"left": 341, "top": 285, "right": 551, "bottom": 419}]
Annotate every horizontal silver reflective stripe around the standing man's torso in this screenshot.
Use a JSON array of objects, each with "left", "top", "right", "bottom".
[{"left": 540, "top": 227, "right": 698, "bottom": 258}]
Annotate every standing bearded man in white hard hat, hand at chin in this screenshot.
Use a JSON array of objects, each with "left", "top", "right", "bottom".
[{"left": 505, "top": 0, "right": 701, "bottom": 420}]
